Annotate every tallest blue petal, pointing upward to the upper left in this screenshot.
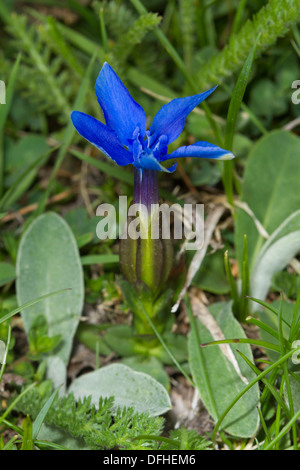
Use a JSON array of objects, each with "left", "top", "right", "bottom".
[{"left": 95, "top": 62, "right": 146, "bottom": 145}]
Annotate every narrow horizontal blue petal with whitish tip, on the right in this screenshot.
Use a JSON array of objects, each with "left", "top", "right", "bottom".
[{"left": 160, "top": 142, "right": 234, "bottom": 161}]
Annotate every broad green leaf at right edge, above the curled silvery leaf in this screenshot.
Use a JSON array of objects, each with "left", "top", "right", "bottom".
[{"left": 235, "top": 130, "right": 300, "bottom": 273}]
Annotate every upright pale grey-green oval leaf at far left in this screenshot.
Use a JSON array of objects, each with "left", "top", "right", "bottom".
[{"left": 17, "top": 212, "right": 84, "bottom": 364}]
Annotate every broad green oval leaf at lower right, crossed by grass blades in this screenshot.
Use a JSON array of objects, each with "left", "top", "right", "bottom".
[{"left": 189, "top": 302, "right": 259, "bottom": 437}]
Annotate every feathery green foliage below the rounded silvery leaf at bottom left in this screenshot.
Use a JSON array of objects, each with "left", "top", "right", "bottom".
[{"left": 16, "top": 389, "right": 163, "bottom": 450}]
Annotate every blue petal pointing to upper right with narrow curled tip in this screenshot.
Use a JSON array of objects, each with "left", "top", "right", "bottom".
[{"left": 150, "top": 87, "right": 216, "bottom": 146}]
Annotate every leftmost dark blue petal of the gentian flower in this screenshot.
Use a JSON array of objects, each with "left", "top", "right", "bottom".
[{"left": 71, "top": 111, "right": 133, "bottom": 166}]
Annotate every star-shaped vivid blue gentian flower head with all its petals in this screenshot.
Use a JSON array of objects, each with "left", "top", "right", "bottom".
[{"left": 71, "top": 62, "right": 234, "bottom": 173}]
